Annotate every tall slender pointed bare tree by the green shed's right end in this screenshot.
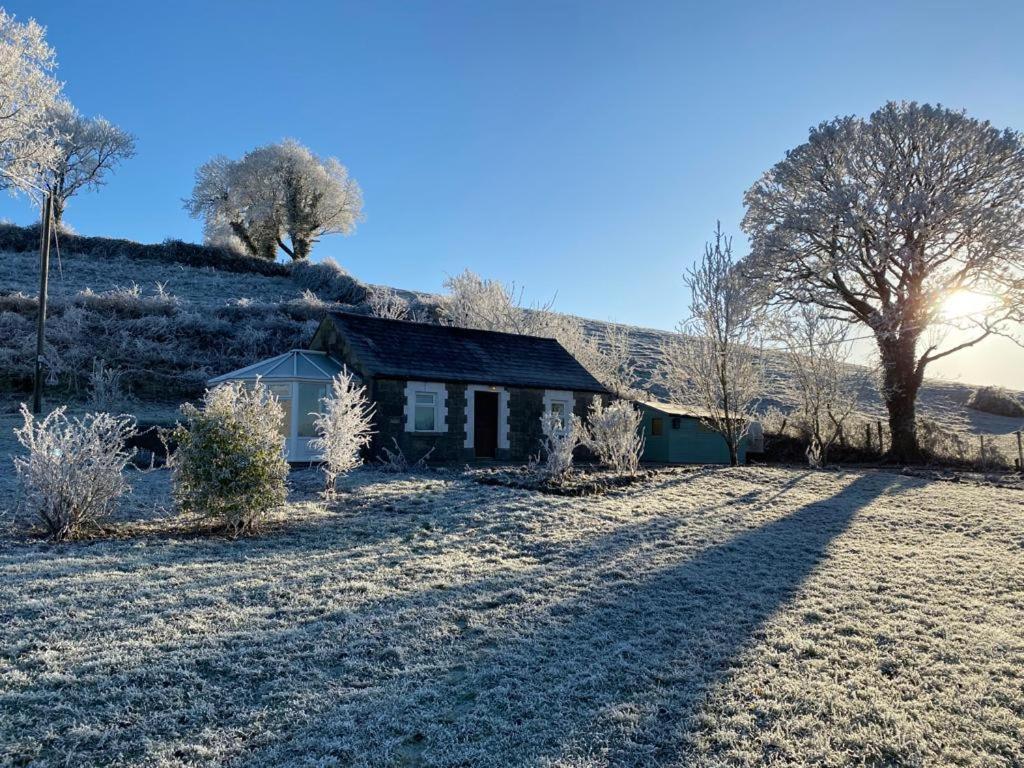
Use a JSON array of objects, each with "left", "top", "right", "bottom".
[{"left": 659, "top": 219, "right": 762, "bottom": 465}]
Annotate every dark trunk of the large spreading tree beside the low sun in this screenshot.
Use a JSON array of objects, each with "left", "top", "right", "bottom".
[{"left": 879, "top": 334, "right": 924, "bottom": 464}]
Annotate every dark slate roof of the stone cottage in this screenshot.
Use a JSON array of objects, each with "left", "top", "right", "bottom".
[{"left": 329, "top": 312, "right": 606, "bottom": 393}]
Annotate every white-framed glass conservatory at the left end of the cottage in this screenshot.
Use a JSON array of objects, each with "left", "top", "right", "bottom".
[{"left": 207, "top": 349, "right": 342, "bottom": 462}]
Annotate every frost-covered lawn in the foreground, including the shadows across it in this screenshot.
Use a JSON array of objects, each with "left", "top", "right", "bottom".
[{"left": 0, "top": 468, "right": 1024, "bottom": 766}]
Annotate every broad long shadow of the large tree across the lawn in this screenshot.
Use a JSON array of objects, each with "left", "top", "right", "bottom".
[{"left": 234, "top": 473, "right": 895, "bottom": 765}]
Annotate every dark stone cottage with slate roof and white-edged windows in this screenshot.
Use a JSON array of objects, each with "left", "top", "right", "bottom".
[{"left": 309, "top": 312, "right": 608, "bottom": 461}]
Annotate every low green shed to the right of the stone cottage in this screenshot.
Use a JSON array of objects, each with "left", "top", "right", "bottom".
[{"left": 637, "top": 400, "right": 748, "bottom": 464}]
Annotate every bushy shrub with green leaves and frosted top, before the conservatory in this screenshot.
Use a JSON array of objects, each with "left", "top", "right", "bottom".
[{"left": 170, "top": 382, "right": 288, "bottom": 536}]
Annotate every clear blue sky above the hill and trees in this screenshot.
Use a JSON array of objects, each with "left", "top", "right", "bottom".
[{"left": 0, "top": 0, "right": 1024, "bottom": 385}]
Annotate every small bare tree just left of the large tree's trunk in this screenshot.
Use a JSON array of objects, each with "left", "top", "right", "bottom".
[{"left": 772, "top": 304, "right": 864, "bottom": 467}]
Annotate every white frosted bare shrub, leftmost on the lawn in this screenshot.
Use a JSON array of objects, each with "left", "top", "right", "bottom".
[{"left": 14, "top": 403, "right": 135, "bottom": 541}]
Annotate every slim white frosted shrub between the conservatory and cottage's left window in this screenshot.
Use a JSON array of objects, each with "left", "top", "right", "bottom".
[{"left": 309, "top": 368, "right": 374, "bottom": 499}]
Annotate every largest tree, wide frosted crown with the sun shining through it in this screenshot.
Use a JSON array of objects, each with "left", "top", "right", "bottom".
[{"left": 743, "top": 102, "right": 1024, "bottom": 461}]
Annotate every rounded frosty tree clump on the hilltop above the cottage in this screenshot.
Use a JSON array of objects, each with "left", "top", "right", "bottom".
[{"left": 185, "top": 139, "right": 362, "bottom": 260}]
